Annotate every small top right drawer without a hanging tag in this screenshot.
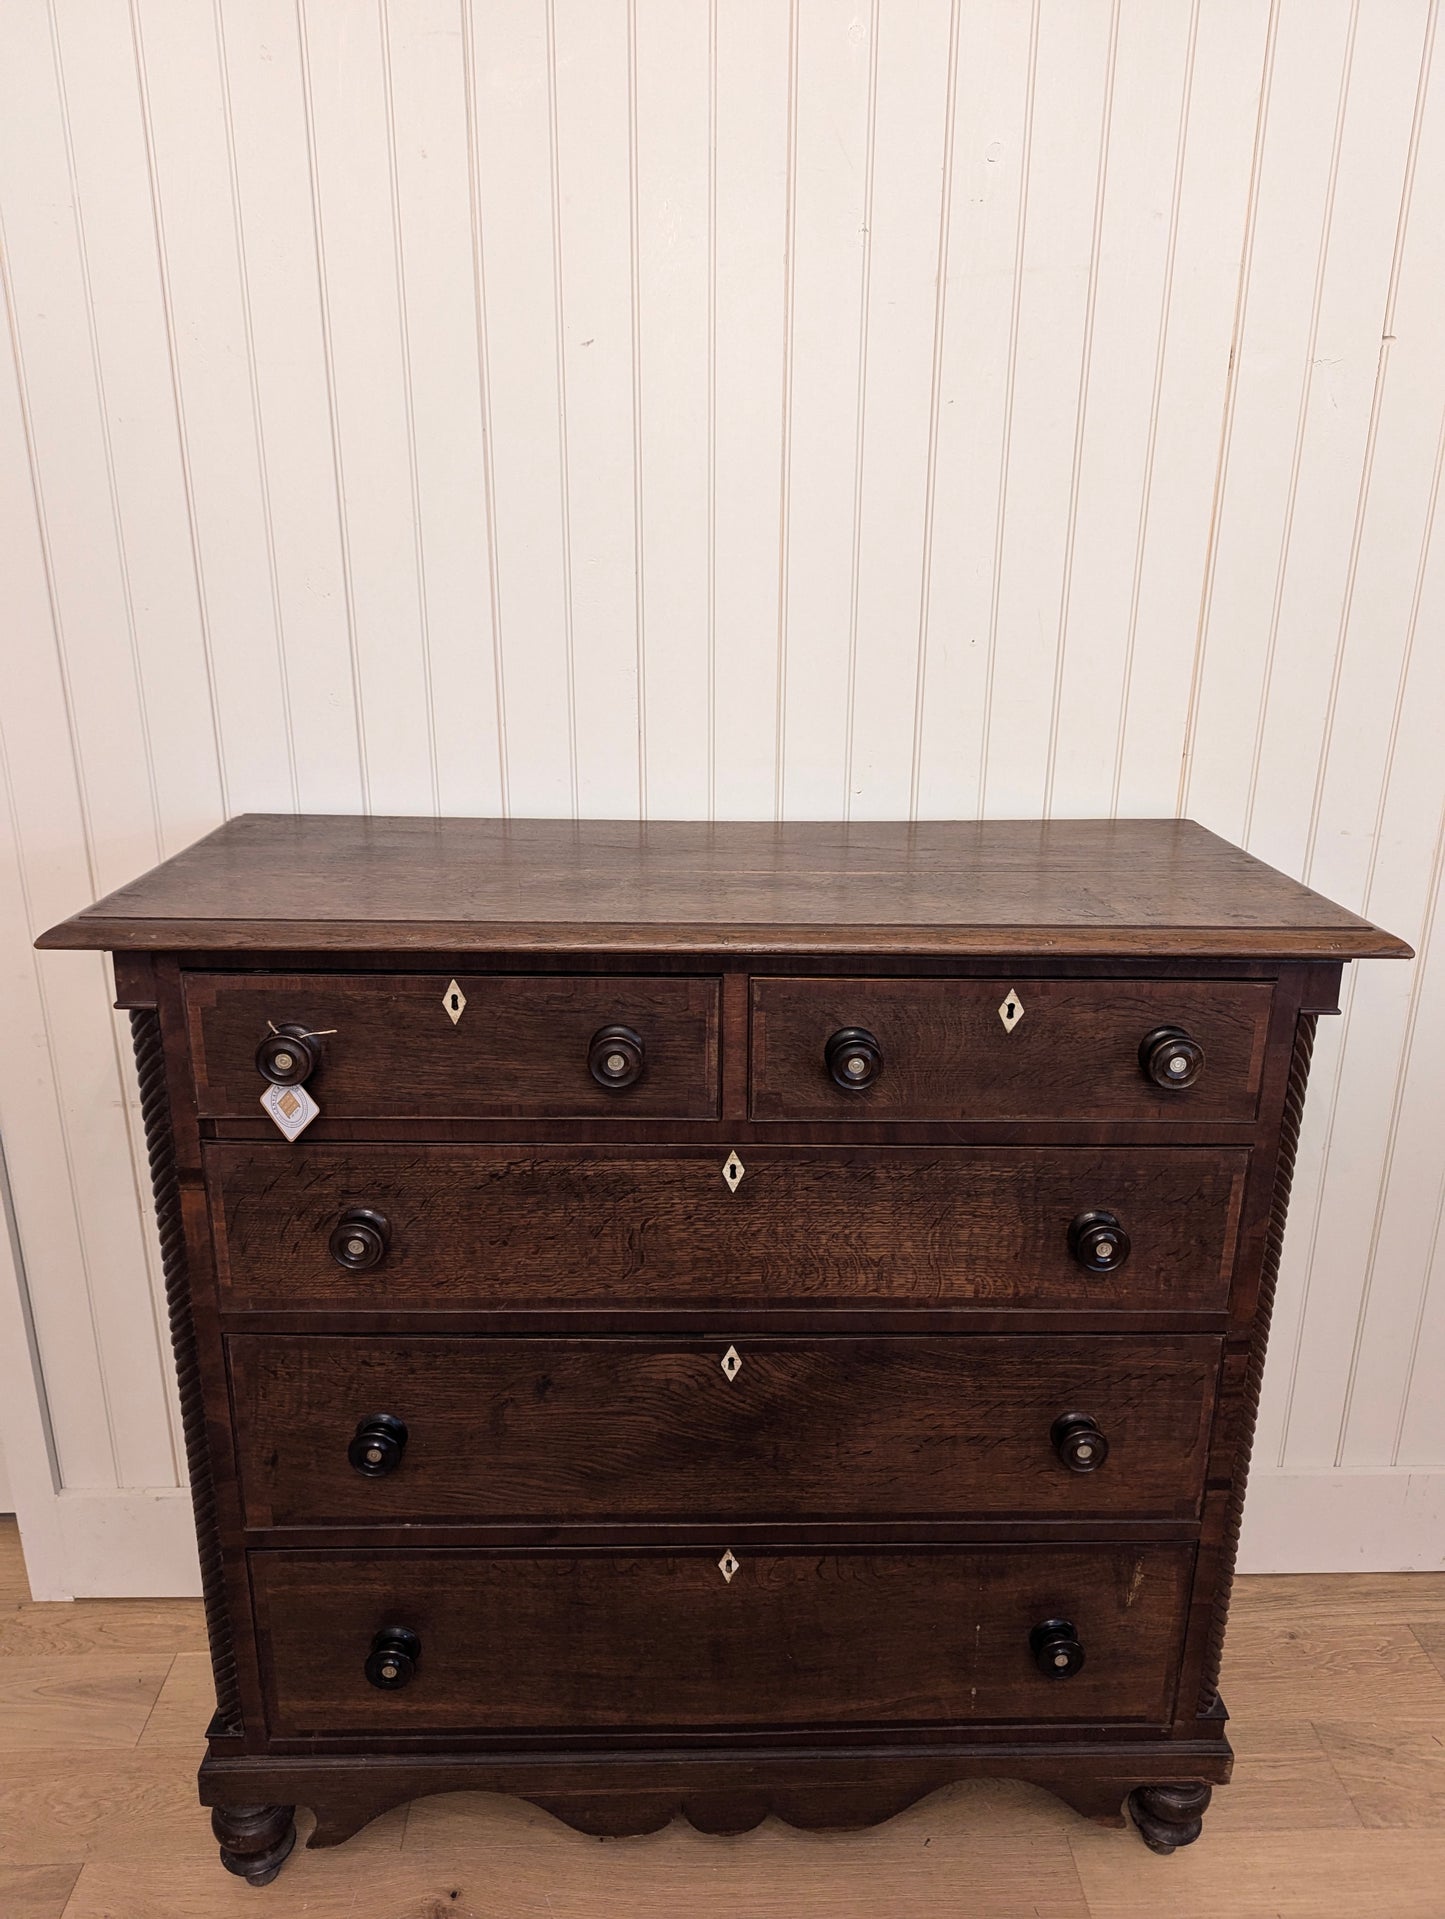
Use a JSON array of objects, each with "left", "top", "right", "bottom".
[{"left": 750, "top": 977, "right": 1272, "bottom": 1123}]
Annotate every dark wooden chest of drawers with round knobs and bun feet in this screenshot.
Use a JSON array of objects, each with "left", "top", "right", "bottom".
[{"left": 40, "top": 816, "right": 1409, "bottom": 1884}]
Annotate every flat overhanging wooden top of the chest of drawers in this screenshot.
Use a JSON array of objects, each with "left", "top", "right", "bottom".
[{"left": 36, "top": 814, "right": 1410, "bottom": 960}]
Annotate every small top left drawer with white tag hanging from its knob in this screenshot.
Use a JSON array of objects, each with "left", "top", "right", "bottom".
[{"left": 186, "top": 973, "right": 720, "bottom": 1119}]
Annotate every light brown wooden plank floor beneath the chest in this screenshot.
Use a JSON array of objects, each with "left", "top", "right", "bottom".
[{"left": 0, "top": 1520, "right": 1445, "bottom": 1919}]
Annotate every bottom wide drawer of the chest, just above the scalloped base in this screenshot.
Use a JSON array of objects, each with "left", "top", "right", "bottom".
[{"left": 249, "top": 1537, "right": 1194, "bottom": 1737}]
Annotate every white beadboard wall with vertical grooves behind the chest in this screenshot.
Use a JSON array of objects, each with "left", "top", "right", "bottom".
[{"left": 0, "top": 0, "right": 1445, "bottom": 1595}]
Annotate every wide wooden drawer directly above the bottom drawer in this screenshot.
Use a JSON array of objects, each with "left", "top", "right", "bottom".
[{"left": 228, "top": 1334, "right": 1220, "bottom": 1526}]
